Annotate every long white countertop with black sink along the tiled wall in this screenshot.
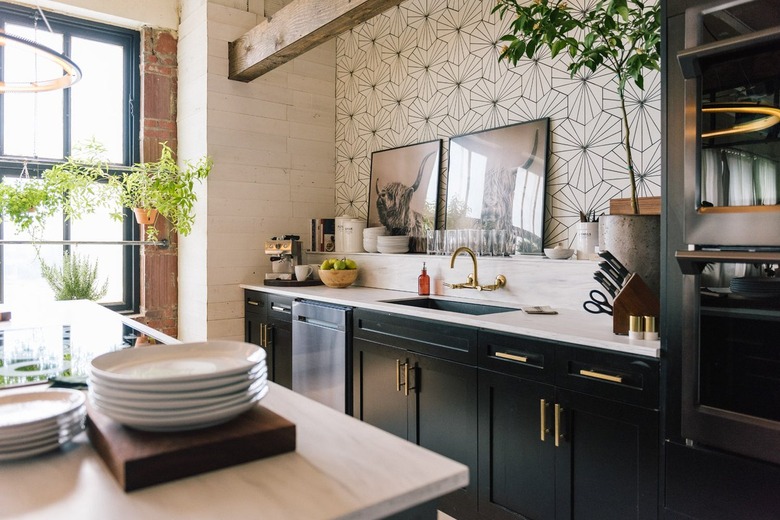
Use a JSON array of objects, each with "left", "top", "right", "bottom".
[{"left": 241, "top": 284, "right": 661, "bottom": 358}]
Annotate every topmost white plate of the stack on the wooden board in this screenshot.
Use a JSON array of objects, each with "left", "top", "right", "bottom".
[{"left": 91, "top": 341, "right": 265, "bottom": 385}]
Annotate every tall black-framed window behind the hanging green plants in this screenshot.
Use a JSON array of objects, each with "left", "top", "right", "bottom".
[{"left": 0, "top": 2, "right": 141, "bottom": 312}]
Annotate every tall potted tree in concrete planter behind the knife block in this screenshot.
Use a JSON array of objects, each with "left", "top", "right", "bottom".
[{"left": 493, "top": 0, "right": 661, "bottom": 292}]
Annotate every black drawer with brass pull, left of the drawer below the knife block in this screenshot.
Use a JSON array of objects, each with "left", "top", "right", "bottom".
[{"left": 478, "top": 330, "right": 555, "bottom": 383}]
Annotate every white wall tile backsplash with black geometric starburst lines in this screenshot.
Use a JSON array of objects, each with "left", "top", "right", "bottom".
[{"left": 336, "top": 0, "right": 661, "bottom": 250}]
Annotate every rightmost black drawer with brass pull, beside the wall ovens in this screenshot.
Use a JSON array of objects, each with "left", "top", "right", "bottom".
[{"left": 555, "top": 345, "right": 660, "bottom": 409}]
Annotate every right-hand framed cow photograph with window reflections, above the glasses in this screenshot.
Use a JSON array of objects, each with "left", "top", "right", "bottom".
[{"left": 445, "top": 118, "right": 550, "bottom": 256}]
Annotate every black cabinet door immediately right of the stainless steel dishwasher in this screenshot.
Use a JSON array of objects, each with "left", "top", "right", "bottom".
[{"left": 352, "top": 338, "right": 414, "bottom": 439}]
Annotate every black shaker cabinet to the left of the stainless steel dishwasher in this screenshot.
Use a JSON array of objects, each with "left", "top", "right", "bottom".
[{"left": 244, "top": 290, "right": 293, "bottom": 388}]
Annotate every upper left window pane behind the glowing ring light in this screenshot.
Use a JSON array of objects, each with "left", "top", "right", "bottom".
[{"left": 2, "top": 24, "right": 64, "bottom": 159}]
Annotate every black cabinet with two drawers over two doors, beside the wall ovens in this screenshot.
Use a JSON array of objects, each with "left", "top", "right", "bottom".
[{"left": 479, "top": 331, "right": 659, "bottom": 520}]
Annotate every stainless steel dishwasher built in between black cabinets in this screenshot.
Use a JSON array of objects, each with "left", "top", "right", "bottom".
[{"left": 292, "top": 300, "right": 352, "bottom": 413}]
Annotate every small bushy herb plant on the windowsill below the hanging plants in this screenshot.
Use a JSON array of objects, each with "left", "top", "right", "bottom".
[{"left": 41, "top": 253, "right": 108, "bottom": 301}]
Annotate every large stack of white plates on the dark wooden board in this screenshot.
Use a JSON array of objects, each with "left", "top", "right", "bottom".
[{"left": 89, "top": 341, "right": 268, "bottom": 431}]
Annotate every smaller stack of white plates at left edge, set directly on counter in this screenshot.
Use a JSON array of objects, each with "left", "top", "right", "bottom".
[{"left": 0, "top": 389, "right": 87, "bottom": 461}]
